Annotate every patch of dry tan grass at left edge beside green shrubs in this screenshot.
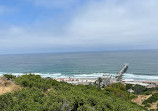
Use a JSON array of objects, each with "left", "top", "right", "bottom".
[{"left": 0, "top": 78, "right": 21, "bottom": 95}]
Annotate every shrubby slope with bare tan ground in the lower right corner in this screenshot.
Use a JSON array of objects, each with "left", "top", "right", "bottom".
[{"left": 126, "top": 85, "right": 158, "bottom": 111}]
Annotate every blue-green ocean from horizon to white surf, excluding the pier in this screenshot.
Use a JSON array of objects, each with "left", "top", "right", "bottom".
[{"left": 0, "top": 50, "right": 158, "bottom": 81}]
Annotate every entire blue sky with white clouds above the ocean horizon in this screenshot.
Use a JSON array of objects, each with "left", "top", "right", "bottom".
[{"left": 0, "top": 0, "right": 158, "bottom": 54}]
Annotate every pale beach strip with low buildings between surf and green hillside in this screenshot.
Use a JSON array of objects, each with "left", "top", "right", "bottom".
[{"left": 0, "top": 75, "right": 158, "bottom": 88}]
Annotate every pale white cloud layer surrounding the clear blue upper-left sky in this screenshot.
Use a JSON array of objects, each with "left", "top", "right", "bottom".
[{"left": 0, "top": 0, "right": 158, "bottom": 51}]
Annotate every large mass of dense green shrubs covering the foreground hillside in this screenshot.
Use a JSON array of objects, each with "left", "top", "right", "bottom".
[{"left": 0, "top": 74, "right": 145, "bottom": 111}]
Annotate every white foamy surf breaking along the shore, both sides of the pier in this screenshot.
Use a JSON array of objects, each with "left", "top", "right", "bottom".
[{"left": 0, "top": 72, "right": 158, "bottom": 81}]
